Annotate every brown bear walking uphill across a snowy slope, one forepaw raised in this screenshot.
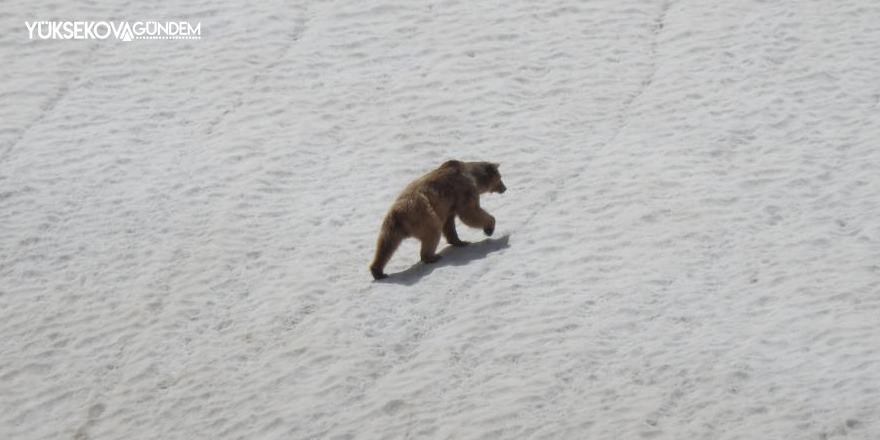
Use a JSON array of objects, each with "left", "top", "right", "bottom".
[{"left": 370, "top": 160, "right": 507, "bottom": 280}]
